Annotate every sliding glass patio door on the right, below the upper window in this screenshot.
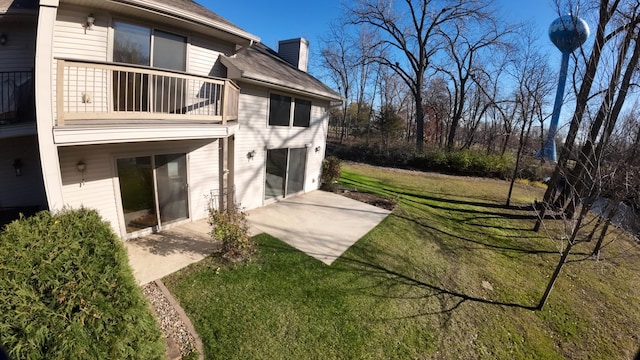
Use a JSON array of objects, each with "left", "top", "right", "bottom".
[{"left": 264, "top": 148, "right": 307, "bottom": 200}]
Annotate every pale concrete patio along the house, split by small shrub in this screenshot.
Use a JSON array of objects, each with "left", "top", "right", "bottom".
[{"left": 125, "top": 191, "right": 390, "bottom": 284}]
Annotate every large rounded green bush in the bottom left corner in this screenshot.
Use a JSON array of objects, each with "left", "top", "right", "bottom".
[{"left": 0, "top": 209, "right": 165, "bottom": 359}]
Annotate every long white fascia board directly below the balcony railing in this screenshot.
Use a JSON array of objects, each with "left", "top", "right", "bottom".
[{"left": 53, "top": 123, "right": 239, "bottom": 146}]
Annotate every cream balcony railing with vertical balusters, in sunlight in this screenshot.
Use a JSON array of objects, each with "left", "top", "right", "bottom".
[{"left": 56, "top": 59, "right": 240, "bottom": 126}]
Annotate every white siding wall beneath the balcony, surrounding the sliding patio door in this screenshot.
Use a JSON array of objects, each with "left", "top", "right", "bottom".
[{"left": 59, "top": 140, "right": 218, "bottom": 236}]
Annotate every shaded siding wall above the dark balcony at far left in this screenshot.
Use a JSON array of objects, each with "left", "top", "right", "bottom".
[{"left": 0, "top": 19, "right": 36, "bottom": 71}]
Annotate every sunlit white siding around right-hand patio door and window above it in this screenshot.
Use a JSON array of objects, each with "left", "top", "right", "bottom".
[{"left": 235, "top": 84, "right": 328, "bottom": 209}]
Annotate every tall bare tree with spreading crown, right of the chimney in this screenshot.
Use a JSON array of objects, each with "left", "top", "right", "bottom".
[{"left": 351, "top": 0, "right": 488, "bottom": 151}]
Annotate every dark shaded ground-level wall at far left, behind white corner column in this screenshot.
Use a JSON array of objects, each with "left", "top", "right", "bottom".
[{"left": 0, "top": 136, "right": 47, "bottom": 208}]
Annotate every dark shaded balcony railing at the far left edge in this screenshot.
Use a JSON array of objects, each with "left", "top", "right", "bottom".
[{"left": 0, "top": 71, "right": 35, "bottom": 126}]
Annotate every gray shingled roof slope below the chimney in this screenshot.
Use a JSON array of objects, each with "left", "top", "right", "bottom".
[{"left": 222, "top": 43, "right": 342, "bottom": 101}]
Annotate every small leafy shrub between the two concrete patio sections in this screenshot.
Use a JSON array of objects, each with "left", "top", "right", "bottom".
[{"left": 209, "top": 207, "right": 255, "bottom": 260}]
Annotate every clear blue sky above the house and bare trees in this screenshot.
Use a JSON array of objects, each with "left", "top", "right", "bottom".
[{"left": 204, "top": 0, "right": 560, "bottom": 61}]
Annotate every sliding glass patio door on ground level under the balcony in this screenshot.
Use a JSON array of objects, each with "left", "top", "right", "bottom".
[{"left": 116, "top": 154, "right": 189, "bottom": 234}]
